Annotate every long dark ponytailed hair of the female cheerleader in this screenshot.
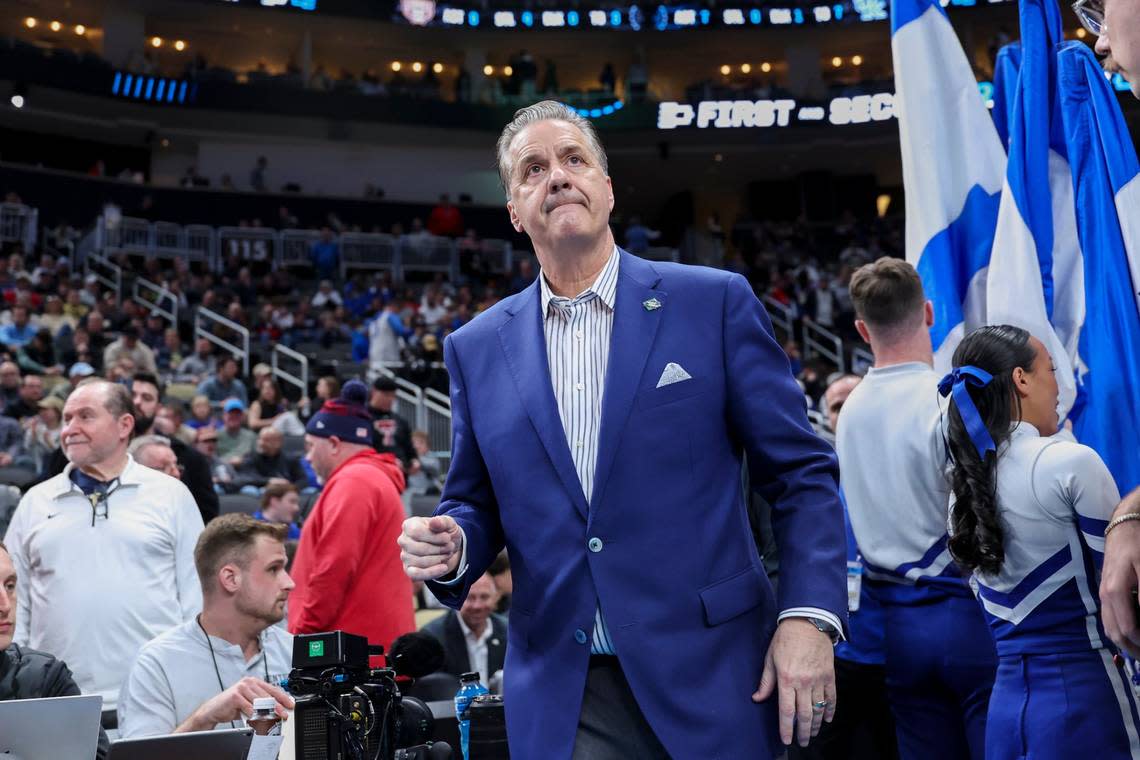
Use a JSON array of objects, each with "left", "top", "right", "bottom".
[{"left": 947, "top": 325, "right": 1036, "bottom": 575}]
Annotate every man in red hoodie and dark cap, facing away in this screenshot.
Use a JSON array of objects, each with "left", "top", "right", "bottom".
[{"left": 288, "top": 381, "right": 416, "bottom": 649}]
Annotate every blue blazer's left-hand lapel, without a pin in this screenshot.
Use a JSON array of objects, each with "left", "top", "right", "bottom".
[{"left": 498, "top": 280, "right": 587, "bottom": 517}]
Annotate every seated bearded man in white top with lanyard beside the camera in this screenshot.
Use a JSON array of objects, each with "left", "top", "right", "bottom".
[{"left": 119, "top": 514, "right": 293, "bottom": 738}]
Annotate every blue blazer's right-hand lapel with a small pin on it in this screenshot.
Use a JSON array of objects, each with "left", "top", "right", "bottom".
[{"left": 589, "top": 251, "right": 666, "bottom": 515}]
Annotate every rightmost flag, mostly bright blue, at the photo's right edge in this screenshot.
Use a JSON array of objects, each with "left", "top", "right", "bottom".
[{"left": 1055, "top": 43, "right": 1140, "bottom": 493}]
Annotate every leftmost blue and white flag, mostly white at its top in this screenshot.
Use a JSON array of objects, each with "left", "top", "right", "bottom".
[{"left": 890, "top": 0, "right": 1005, "bottom": 371}]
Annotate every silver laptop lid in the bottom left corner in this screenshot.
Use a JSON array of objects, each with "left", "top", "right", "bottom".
[{"left": 0, "top": 694, "right": 103, "bottom": 760}]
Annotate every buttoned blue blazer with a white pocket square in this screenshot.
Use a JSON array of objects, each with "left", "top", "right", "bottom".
[{"left": 431, "top": 252, "right": 847, "bottom": 760}]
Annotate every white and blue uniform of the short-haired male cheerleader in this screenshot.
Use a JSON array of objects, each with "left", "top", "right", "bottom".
[{"left": 836, "top": 362, "right": 996, "bottom": 760}]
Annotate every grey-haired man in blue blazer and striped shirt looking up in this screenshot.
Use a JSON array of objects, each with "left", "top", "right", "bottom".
[{"left": 400, "top": 101, "right": 847, "bottom": 760}]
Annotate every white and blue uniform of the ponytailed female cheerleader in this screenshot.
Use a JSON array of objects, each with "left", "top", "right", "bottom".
[{"left": 974, "top": 422, "right": 1140, "bottom": 760}]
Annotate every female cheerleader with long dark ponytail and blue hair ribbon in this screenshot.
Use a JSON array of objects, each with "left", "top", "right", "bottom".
[{"left": 938, "top": 325, "right": 1140, "bottom": 760}]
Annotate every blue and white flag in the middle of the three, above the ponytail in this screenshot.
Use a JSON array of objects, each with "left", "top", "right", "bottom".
[{"left": 986, "top": 0, "right": 1084, "bottom": 419}]
